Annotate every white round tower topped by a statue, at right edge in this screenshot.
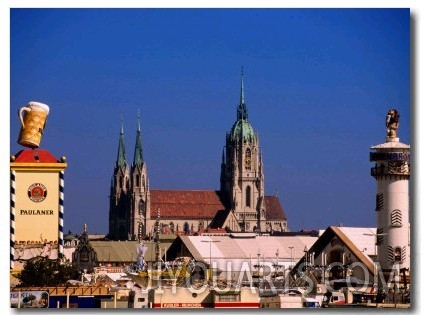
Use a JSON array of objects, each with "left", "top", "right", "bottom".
[{"left": 370, "top": 109, "right": 411, "bottom": 289}]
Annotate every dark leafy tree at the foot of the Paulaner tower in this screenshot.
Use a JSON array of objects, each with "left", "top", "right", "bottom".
[{"left": 19, "top": 256, "right": 77, "bottom": 286}]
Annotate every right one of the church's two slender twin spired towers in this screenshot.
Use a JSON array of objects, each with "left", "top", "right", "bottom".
[{"left": 130, "top": 114, "right": 150, "bottom": 240}]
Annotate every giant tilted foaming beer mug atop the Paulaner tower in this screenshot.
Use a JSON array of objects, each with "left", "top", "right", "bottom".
[{"left": 18, "top": 102, "right": 49, "bottom": 148}]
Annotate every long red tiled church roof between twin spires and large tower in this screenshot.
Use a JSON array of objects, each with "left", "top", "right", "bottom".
[{"left": 151, "top": 189, "right": 226, "bottom": 220}]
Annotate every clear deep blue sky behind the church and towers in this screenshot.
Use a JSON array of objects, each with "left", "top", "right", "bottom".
[{"left": 10, "top": 9, "right": 411, "bottom": 233}]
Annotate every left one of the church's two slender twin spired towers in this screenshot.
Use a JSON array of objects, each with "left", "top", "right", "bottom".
[{"left": 109, "top": 121, "right": 130, "bottom": 240}]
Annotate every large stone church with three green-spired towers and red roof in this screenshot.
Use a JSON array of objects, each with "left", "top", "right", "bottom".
[{"left": 108, "top": 73, "right": 289, "bottom": 240}]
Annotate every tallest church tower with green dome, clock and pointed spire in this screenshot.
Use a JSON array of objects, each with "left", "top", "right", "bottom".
[{"left": 220, "top": 69, "right": 266, "bottom": 231}]
